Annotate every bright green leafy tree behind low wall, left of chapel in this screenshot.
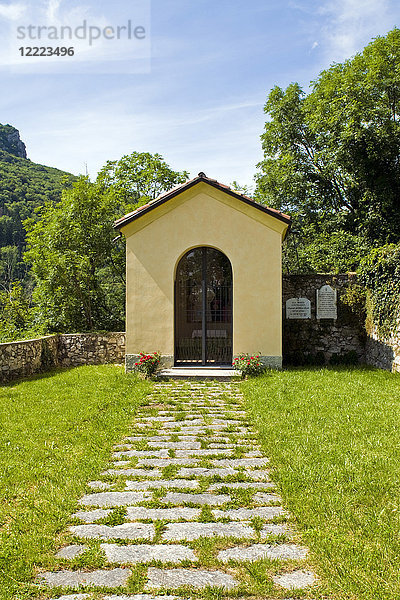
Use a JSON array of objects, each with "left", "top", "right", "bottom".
[{"left": 25, "top": 177, "right": 124, "bottom": 331}]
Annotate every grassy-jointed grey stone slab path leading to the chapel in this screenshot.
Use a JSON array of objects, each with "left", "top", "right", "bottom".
[{"left": 37, "top": 382, "right": 316, "bottom": 600}]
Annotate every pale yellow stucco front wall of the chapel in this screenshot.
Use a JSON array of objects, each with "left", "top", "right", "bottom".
[{"left": 121, "top": 183, "right": 287, "bottom": 364}]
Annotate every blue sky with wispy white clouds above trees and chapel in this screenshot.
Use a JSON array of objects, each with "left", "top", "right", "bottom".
[{"left": 0, "top": 0, "right": 400, "bottom": 184}]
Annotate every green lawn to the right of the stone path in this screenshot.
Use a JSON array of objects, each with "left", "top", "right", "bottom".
[{"left": 242, "top": 368, "right": 400, "bottom": 600}]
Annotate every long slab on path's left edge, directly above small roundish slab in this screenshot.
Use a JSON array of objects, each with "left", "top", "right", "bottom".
[{"left": 69, "top": 523, "right": 155, "bottom": 540}]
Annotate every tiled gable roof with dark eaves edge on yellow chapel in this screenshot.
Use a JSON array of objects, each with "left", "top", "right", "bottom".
[{"left": 114, "top": 172, "right": 291, "bottom": 230}]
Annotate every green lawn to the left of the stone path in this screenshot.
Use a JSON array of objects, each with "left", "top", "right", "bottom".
[{"left": 0, "top": 365, "right": 150, "bottom": 600}]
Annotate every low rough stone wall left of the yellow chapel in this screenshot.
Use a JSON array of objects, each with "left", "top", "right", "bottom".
[{"left": 0, "top": 332, "right": 125, "bottom": 382}]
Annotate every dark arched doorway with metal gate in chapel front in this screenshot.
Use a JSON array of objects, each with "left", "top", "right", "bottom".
[{"left": 175, "top": 247, "right": 233, "bottom": 365}]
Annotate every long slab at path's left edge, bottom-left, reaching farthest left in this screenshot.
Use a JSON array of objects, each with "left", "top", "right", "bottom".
[{"left": 37, "top": 569, "right": 131, "bottom": 589}]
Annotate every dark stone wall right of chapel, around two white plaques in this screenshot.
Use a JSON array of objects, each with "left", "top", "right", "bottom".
[{"left": 282, "top": 273, "right": 366, "bottom": 364}]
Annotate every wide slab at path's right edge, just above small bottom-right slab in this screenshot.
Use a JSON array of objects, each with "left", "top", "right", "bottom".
[{"left": 217, "top": 544, "right": 308, "bottom": 562}]
